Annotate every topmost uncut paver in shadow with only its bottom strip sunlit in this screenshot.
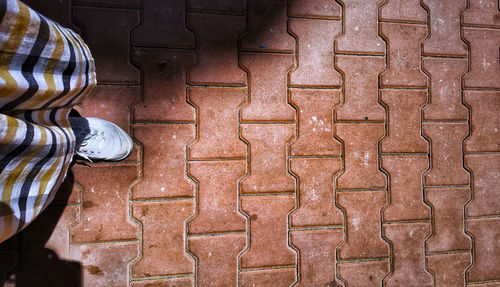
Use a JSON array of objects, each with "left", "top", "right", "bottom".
[{"left": 188, "top": 13, "right": 247, "bottom": 86}]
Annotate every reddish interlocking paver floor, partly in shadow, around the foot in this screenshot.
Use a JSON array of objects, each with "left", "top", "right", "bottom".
[{"left": 0, "top": 0, "right": 500, "bottom": 287}]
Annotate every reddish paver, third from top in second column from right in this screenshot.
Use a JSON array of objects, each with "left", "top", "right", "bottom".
[{"left": 423, "top": 123, "right": 469, "bottom": 186}]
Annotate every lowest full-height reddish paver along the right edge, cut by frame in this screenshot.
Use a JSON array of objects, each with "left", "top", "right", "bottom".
[{"left": 466, "top": 218, "right": 500, "bottom": 282}]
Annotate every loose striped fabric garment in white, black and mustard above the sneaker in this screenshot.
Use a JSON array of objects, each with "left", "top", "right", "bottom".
[{"left": 0, "top": 0, "right": 96, "bottom": 242}]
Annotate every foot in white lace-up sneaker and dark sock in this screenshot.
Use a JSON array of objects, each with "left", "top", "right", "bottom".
[{"left": 69, "top": 117, "right": 133, "bottom": 161}]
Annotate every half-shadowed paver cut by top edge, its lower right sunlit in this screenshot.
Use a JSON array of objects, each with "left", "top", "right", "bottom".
[{"left": 240, "top": 0, "right": 295, "bottom": 52}]
